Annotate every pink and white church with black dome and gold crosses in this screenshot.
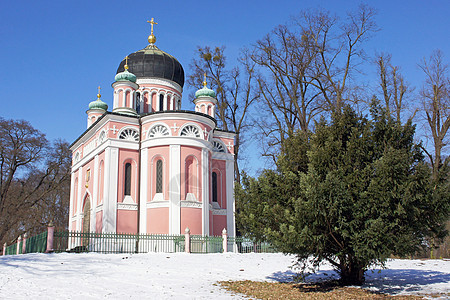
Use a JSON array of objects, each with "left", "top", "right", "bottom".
[{"left": 69, "top": 18, "right": 235, "bottom": 236}]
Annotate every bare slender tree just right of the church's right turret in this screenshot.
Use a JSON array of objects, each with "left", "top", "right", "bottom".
[{"left": 187, "top": 46, "right": 258, "bottom": 182}]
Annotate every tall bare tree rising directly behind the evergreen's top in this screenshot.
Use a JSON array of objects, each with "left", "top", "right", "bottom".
[{"left": 304, "top": 5, "right": 378, "bottom": 112}]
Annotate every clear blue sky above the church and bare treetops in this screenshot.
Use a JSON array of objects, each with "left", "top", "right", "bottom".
[{"left": 0, "top": 0, "right": 450, "bottom": 173}]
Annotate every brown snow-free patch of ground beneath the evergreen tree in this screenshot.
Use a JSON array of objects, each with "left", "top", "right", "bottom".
[{"left": 219, "top": 280, "right": 423, "bottom": 300}]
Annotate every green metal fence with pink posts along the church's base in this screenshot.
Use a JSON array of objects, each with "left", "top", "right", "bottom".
[{"left": 4, "top": 230, "right": 276, "bottom": 255}]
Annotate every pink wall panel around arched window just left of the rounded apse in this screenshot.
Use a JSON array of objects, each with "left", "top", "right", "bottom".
[{"left": 117, "top": 149, "right": 139, "bottom": 203}]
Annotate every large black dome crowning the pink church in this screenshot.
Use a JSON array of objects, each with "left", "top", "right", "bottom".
[{"left": 117, "top": 45, "right": 184, "bottom": 87}]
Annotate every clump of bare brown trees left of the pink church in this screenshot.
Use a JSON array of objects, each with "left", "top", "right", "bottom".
[{"left": 0, "top": 119, "right": 71, "bottom": 243}]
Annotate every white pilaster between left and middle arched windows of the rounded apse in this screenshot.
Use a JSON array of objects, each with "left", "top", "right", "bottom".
[{"left": 169, "top": 145, "right": 181, "bottom": 234}]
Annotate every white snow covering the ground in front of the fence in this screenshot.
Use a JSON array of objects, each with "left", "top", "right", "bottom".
[{"left": 0, "top": 253, "right": 450, "bottom": 300}]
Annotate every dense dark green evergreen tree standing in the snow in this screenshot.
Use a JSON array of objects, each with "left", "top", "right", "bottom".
[{"left": 236, "top": 103, "right": 449, "bottom": 284}]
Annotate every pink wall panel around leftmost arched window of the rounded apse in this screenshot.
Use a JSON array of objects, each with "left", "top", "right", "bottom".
[{"left": 147, "top": 146, "right": 170, "bottom": 202}]
